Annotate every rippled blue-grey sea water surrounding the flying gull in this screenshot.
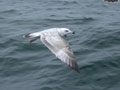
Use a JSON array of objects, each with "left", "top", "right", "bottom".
[{"left": 0, "top": 0, "right": 120, "bottom": 90}]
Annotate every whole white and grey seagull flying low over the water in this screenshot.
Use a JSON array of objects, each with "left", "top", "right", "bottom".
[{"left": 23, "top": 28, "right": 79, "bottom": 72}]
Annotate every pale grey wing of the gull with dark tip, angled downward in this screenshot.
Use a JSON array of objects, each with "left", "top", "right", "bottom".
[{"left": 41, "top": 34, "right": 79, "bottom": 72}]
